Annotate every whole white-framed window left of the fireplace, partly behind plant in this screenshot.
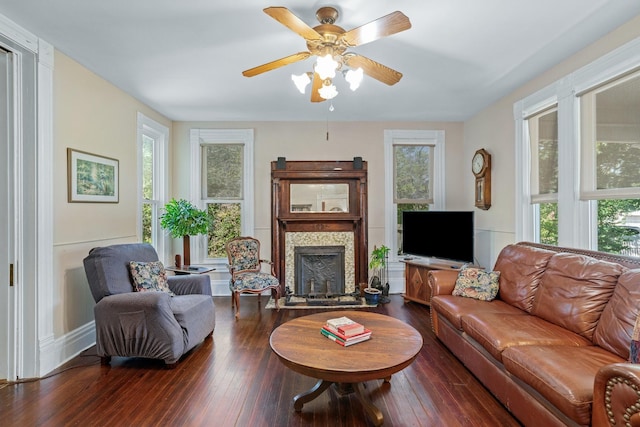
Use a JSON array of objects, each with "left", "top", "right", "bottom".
[{"left": 191, "top": 129, "right": 253, "bottom": 262}]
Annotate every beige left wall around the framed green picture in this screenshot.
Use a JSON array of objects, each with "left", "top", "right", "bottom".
[{"left": 52, "top": 52, "right": 171, "bottom": 337}]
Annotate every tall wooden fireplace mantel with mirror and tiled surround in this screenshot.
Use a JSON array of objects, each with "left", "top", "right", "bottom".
[{"left": 271, "top": 157, "right": 368, "bottom": 295}]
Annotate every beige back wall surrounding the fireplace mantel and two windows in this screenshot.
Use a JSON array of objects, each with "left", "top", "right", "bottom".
[{"left": 171, "top": 122, "right": 463, "bottom": 256}]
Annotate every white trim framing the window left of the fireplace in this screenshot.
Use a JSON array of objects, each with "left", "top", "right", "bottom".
[{"left": 189, "top": 129, "right": 255, "bottom": 264}]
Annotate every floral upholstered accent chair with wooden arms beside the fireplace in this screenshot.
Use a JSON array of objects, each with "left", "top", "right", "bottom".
[{"left": 226, "top": 237, "right": 280, "bottom": 318}]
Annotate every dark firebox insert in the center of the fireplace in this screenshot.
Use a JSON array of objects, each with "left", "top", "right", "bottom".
[{"left": 294, "top": 246, "right": 345, "bottom": 295}]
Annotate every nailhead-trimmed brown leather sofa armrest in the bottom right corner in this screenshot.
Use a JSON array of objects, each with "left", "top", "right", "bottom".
[{"left": 592, "top": 363, "right": 640, "bottom": 427}]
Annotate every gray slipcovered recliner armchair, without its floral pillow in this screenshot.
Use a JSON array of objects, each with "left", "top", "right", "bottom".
[{"left": 84, "top": 243, "right": 215, "bottom": 366}]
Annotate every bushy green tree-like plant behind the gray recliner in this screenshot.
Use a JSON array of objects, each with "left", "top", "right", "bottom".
[{"left": 160, "top": 199, "right": 209, "bottom": 265}]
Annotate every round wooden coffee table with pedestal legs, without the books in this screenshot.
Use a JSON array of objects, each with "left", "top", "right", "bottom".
[{"left": 269, "top": 310, "right": 422, "bottom": 425}]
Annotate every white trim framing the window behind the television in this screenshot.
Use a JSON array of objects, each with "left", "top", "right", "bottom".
[{"left": 384, "top": 129, "right": 446, "bottom": 262}]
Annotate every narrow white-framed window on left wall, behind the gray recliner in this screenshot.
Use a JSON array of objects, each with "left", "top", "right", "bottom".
[{"left": 138, "top": 113, "right": 169, "bottom": 259}]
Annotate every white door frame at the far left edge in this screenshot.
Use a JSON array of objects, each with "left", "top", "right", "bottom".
[{"left": 0, "top": 15, "right": 55, "bottom": 381}]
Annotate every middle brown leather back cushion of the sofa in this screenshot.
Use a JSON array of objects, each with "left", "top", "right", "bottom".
[{"left": 531, "top": 253, "right": 625, "bottom": 339}]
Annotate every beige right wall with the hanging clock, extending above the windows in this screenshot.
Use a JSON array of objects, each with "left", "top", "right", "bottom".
[{"left": 462, "top": 16, "right": 640, "bottom": 265}]
